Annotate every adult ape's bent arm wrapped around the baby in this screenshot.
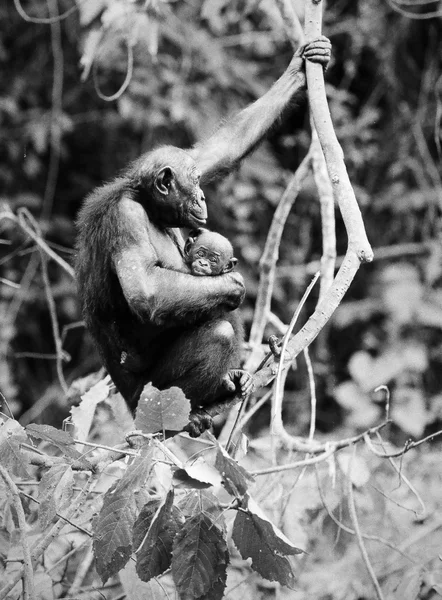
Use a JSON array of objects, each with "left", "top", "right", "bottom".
[{"left": 112, "top": 200, "right": 245, "bottom": 327}]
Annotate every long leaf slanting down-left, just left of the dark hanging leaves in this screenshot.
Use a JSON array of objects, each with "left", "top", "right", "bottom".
[{"left": 94, "top": 448, "right": 152, "bottom": 583}]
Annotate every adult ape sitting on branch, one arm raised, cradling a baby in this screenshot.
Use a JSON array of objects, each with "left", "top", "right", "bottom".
[{"left": 77, "top": 37, "right": 330, "bottom": 432}]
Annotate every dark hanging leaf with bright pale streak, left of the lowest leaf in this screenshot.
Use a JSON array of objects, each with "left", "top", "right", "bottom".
[{"left": 133, "top": 490, "right": 181, "bottom": 581}]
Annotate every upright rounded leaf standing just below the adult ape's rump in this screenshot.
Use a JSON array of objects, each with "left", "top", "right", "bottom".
[{"left": 135, "top": 383, "right": 190, "bottom": 433}]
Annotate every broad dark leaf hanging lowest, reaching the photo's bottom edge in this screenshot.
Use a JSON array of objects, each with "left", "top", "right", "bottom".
[{"left": 172, "top": 513, "right": 228, "bottom": 600}]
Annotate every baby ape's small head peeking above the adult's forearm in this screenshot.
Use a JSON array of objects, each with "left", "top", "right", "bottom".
[{"left": 184, "top": 228, "right": 238, "bottom": 275}]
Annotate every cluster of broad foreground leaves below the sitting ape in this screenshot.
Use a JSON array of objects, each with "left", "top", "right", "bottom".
[{"left": 0, "top": 384, "right": 302, "bottom": 600}]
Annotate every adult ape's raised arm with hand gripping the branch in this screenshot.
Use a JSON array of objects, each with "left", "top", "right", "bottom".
[{"left": 191, "top": 36, "right": 331, "bottom": 183}]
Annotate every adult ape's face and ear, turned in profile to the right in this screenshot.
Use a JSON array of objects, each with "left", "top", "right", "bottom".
[{"left": 154, "top": 149, "right": 207, "bottom": 227}]
